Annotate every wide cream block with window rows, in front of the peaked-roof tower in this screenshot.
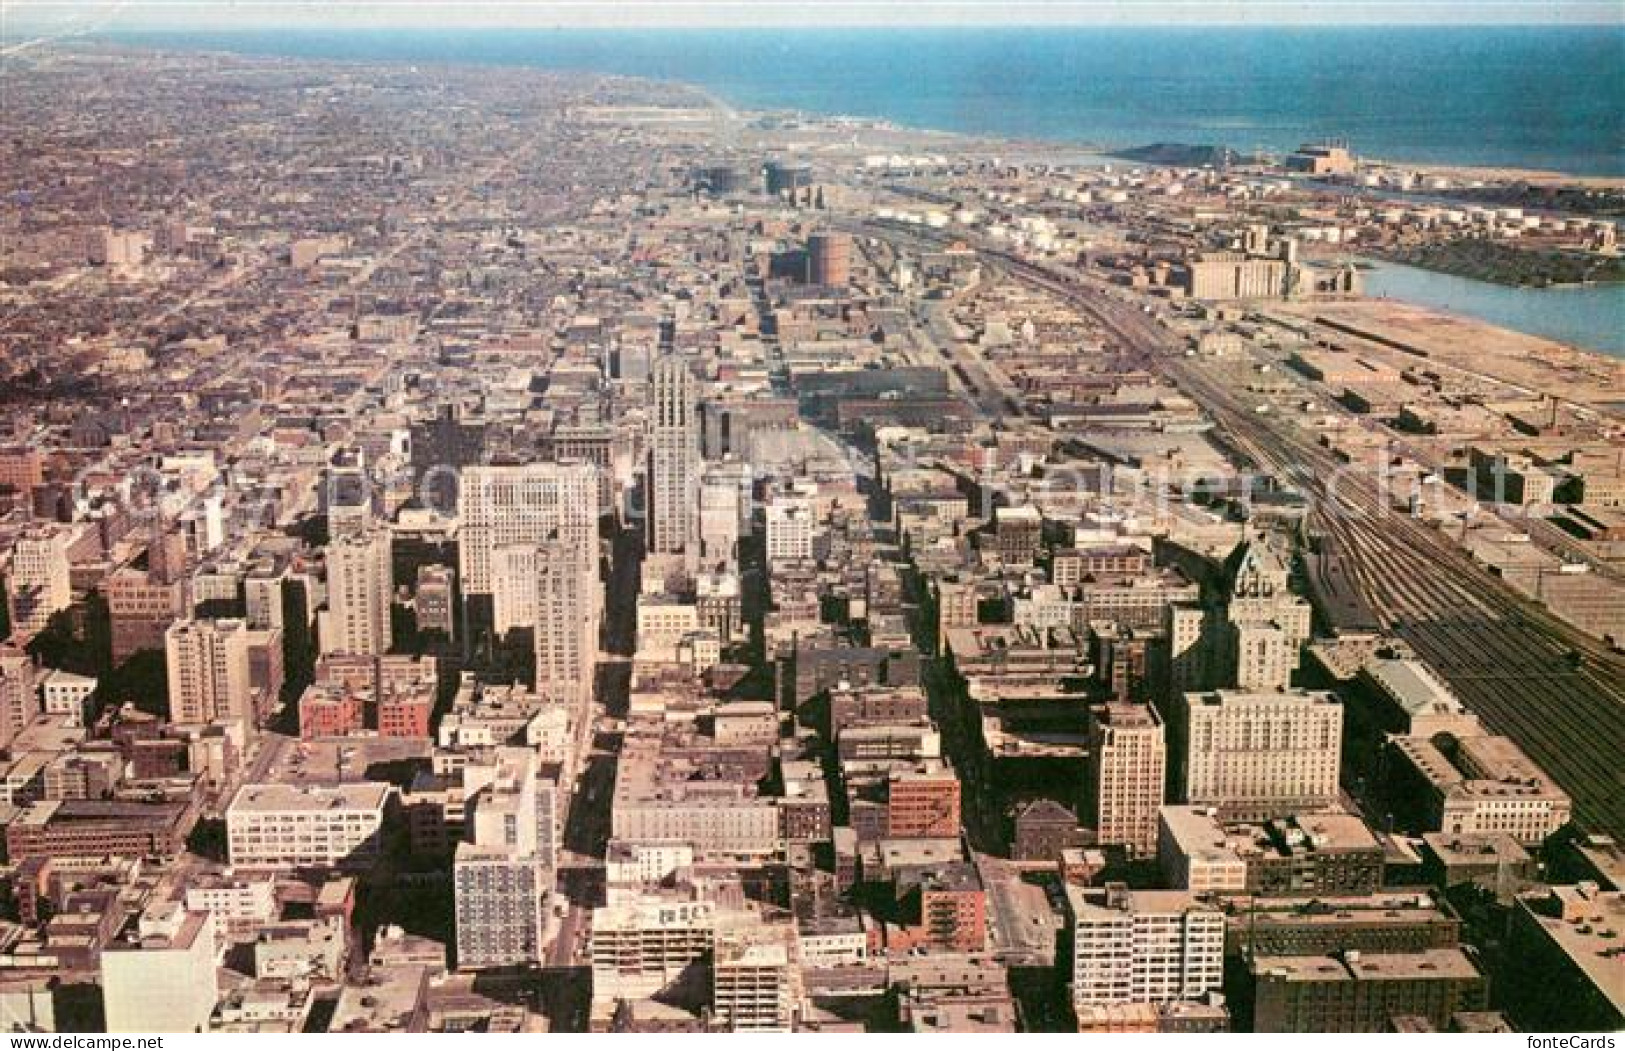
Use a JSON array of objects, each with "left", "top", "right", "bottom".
[{"left": 1175, "top": 690, "right": 1342, "bottom": 820}]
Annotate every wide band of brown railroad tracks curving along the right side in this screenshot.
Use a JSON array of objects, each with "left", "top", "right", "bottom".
[{"left": 856, "top": 224, "right": 1625, "bottom": 837}]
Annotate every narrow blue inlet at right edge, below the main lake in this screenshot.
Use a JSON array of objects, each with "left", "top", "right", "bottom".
[{"left": 1365, "top": 263, "right": 1625, "bottom": 357}]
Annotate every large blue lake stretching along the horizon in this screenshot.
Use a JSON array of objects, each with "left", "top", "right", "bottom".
[{"left": 95, "top": 26, "right": 1625, "bottom": 174}]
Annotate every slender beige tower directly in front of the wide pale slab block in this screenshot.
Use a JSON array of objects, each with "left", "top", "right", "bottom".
[{"left": 536, "top": 541, "right": 601, "bottom": 702}]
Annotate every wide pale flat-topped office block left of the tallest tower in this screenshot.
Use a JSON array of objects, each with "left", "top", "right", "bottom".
[{"left": 458, "top": 463, "right": 598, "bottom": 596}]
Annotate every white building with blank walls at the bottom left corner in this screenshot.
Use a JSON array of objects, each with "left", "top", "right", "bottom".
[{"left": 101, "top": 902, "right": 219, "bottom": 1033}]
